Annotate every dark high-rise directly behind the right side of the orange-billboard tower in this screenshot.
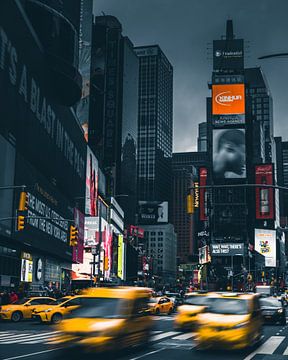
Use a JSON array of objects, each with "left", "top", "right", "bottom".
[{"left": 244, "top": 67, "right": 273, "bottom": 163}]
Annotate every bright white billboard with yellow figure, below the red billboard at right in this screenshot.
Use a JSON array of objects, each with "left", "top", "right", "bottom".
[{"left": 255, "top": 229, "right": 276, "bottom": 267}]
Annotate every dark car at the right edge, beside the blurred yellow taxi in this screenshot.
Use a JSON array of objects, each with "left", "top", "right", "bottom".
[{"left": 260, "top": 297, "right": 286, "bottom": 325}]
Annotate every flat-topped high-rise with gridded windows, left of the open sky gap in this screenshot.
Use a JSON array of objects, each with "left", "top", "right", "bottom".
[{"left": 134, "top": 45, "right": 173, "bottom": 205}]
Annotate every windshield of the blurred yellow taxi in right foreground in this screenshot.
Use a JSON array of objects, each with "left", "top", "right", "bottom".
[{"left": 209, "top": 298, "right": 248, "bottom": 315}]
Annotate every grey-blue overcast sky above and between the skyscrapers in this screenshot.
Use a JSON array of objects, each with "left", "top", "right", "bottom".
[{"left": 94, "top": 0, "right": 288, "bottom": 151}]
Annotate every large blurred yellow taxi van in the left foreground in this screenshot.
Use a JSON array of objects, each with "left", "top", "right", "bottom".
[{"left": 52, "top": 287, "right": 152, "bottom": 352}]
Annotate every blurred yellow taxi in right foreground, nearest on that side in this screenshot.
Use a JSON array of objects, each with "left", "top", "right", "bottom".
[{"left": 197, "top": 293, "right": 263, "bottom": 349}]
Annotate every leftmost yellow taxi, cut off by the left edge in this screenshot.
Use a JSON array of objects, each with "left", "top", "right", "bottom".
[{"left": 0, "top": 296, "right": 56, "bottom": 322}]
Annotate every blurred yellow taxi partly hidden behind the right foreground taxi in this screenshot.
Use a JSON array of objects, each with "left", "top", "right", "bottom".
[{"left": 174, "top": 292, "right": 207, "bottom": 330}]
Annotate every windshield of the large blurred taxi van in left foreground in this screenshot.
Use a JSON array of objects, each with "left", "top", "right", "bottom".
[{"left": 71, "top": 298, "right": 128, "bottom": 319}]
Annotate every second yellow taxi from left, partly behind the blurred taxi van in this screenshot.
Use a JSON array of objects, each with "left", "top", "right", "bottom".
[{"left": 32, "top": 295, "right": 85, "bottom": 324}]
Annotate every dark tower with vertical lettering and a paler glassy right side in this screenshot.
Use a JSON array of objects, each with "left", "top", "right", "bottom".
[{"left": 89, "top": 16, "right": 139, "bottom": 224}]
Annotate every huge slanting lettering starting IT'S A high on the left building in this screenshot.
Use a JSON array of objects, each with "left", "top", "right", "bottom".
[{"left": 0, "top": 27, "right": 85, "bottom": 179}]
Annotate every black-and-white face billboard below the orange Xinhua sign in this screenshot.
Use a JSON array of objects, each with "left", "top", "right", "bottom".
[{"left": 213, "top": 129, "right": 246, "bottom": 179}]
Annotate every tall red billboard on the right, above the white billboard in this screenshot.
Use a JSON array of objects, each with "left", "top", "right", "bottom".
[{"left": 255, "top": 164, "right": 275, "bottom": 220}]
